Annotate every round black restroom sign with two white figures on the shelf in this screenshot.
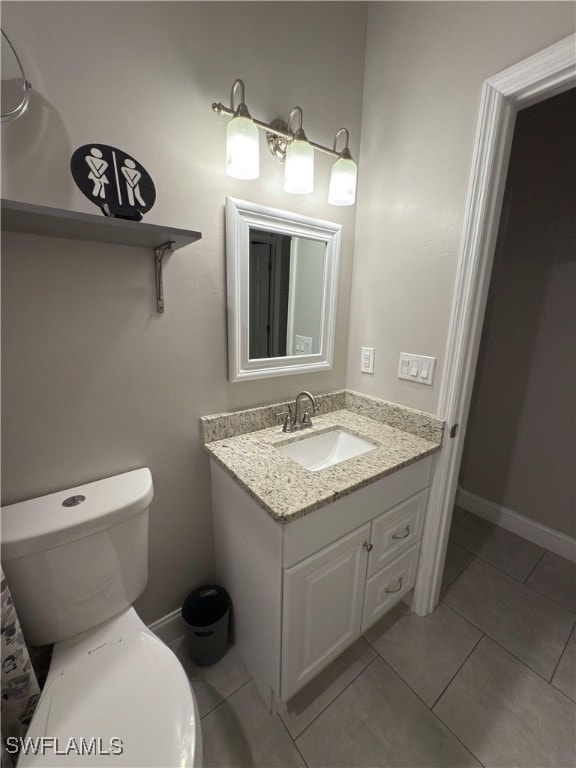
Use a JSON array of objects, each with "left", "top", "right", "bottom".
[{"left": 70, "top": 144, "right": 156, "bottom": 221}]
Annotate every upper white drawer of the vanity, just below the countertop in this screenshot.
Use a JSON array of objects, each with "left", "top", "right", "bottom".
[{"left": 368, "top": 490, "right": 428, "bottom": 576}]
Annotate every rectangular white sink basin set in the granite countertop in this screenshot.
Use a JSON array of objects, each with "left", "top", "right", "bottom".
[{"left": 278, "top": 429, "right": 376, "bottom": 472}]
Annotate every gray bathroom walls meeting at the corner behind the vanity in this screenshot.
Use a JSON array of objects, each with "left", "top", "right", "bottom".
[{"left": 2, "top": 2, "right": 574, "bottom": 621}]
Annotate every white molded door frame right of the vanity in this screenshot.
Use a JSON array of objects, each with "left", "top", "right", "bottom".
[{"left": 412, "top": 35, "right": 576, "bottom": 616}]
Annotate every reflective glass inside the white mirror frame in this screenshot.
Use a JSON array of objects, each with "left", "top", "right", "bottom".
[{"left": 248, "top": 228, "right": 326, "bottom": 360}]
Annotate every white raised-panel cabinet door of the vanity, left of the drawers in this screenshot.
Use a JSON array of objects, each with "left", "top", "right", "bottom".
[{"left": 282, "top": 523, "right": 370, "bottom": 700}]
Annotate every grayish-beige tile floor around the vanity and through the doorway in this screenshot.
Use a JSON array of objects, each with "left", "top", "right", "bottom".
[{"left": 172, "top": 508, "right": 576, "bottom": 768}]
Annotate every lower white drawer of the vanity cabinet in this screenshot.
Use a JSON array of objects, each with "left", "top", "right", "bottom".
[{"left": 362, "top": 544, "right": 420, "bottom": 632}]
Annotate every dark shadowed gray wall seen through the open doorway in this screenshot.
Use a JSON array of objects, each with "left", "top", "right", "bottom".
[{"left": 460, "top": 89, "right": 576, "bottom": 536}]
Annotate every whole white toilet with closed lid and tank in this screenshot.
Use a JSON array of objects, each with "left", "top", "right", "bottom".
[{"left": 1, "top": 469, "right": 202, "bottom": 768}]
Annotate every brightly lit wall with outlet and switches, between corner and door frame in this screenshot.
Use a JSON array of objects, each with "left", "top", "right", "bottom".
[{"left": 347, "top": 2, "right": 575, "bottom": 413}]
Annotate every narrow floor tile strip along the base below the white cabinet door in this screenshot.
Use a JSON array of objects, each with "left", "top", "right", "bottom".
[{"left": 279, "top": 638, "right": 376, "bottom": 738}]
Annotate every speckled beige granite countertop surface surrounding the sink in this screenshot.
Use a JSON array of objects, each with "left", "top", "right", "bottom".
[{"left": 205, "top": 401, "right": 443, "bottom": 522}]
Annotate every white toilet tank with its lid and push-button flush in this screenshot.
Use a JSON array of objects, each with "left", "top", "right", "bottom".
[{"left": 2, "top": 469, "right": 154, "bottom": 645}]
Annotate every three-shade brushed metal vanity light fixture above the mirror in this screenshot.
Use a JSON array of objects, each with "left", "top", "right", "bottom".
[{"left": 212, "top": 80, "right": 358, "bottom": 205}]
